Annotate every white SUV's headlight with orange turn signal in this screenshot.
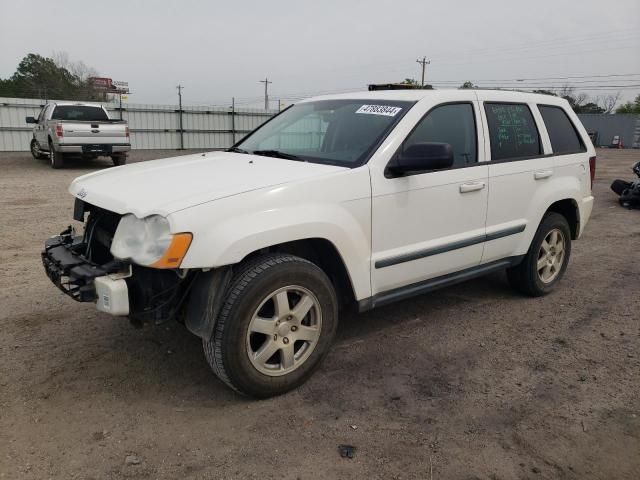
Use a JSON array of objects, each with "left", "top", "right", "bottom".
[{"left": 111, "top": 214, "right": 192, "bottom": 268}]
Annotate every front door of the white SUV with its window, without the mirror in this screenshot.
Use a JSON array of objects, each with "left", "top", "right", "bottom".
[{"left": 371, "top": 101, "right": 488, "bottom": 295}]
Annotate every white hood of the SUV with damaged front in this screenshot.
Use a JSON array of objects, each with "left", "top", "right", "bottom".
[{"left": 69, "top": 152, "right": 345, "bottom": 218}]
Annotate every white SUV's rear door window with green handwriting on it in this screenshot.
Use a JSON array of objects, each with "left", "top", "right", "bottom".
[{"left": 484, "top": 103, "right": 542, "bottom": 160}]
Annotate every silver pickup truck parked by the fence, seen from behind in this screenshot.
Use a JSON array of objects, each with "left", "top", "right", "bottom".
[{"left": 26, "top": 103, "right": 131, "bottom": 168}]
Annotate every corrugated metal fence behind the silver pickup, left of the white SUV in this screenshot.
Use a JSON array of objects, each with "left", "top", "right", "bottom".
[{"left": 0, "top": 98, "right": 277, "bottom": 151}]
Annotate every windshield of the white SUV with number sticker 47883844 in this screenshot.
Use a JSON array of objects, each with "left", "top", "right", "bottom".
[{"left": 235, "top": 100, "right": 414, "bottom": 167}]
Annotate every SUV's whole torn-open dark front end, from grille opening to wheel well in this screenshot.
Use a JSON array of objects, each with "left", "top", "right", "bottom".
[{"left": 42, "top": 199, "right": 197, "bottom": 323}]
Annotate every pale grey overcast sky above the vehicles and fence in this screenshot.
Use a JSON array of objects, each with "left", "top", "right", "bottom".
[{"left": 0, "top": 0, "right": 640, "bottom": 106}]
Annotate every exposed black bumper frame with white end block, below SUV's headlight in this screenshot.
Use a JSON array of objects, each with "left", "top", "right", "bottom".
[{"left": 42, "top": 227, "right": 131, "bottom": 315}]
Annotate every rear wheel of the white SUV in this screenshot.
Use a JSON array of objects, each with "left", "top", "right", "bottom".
[{"left": 507, "top": 212, "right": 571, "bottom": 297}]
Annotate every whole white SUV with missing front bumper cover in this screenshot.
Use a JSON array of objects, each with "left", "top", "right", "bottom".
[{"left": 42, "top": 90, "right": 595, "bottom": 397}]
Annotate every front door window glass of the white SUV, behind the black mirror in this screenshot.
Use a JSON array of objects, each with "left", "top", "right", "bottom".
[{"left": 402, "top": 103, "right": 478, "bottom": 167}]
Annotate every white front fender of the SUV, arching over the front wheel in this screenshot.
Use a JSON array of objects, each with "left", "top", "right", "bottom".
[{"left": 170, "top": 167, "right": 371, "bottom": 299}]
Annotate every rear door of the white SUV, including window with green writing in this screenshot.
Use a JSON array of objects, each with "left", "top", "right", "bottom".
[{"left": 478, "top": 96, "right": 554, "bottom": 263}]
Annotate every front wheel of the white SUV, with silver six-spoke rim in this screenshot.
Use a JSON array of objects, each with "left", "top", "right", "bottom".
[{"left": 203, "top": 254, "right": 338, "bottom": 398}]
